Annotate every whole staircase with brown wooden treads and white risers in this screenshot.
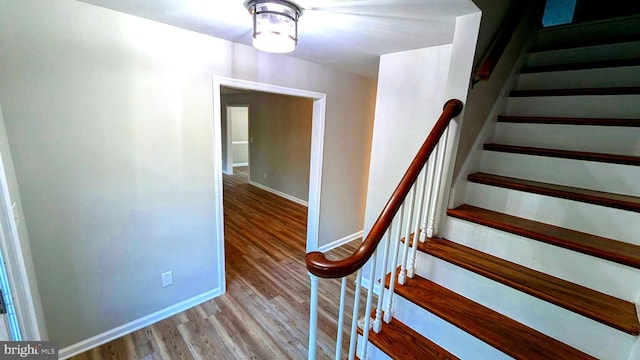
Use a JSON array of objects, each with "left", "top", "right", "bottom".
[{"left": 368, "top": 18, "right": 640, "bottom": 360}]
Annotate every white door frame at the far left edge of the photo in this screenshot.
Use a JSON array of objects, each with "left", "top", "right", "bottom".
[{"left": 0, "top": 107, "right": 47, "bottom": 340}]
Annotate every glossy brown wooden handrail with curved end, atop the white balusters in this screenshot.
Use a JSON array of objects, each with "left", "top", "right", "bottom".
[{"left": 305, "top": 99, "right": 462, "bottom": 278}]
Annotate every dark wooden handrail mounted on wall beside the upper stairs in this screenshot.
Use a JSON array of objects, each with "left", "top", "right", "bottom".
[{"left": 473, "top": 0, "right": 537, "bottom": 84}]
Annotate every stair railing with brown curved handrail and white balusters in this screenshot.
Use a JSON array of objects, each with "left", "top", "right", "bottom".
[{"left": 305, "top": 99, "right": 463, "bottom": 360}]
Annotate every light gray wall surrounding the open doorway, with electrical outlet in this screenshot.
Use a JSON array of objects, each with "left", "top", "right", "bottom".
[{"left": 0, "top": 0, "right": 375, "bottom": 347}]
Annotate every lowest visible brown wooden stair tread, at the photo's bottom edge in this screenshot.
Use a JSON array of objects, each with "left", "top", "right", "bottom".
[{"left": 358, "top": 318, "right": 458, "bottom": 360}]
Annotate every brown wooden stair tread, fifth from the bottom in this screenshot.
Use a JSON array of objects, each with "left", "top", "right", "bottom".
[{"left": 467, "top": 172, "right": 640, "bottom": 212}]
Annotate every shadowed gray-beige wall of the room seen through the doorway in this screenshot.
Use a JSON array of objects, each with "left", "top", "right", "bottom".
[{"left": 222, "top": 92, "right": 313, "bottom": 202}]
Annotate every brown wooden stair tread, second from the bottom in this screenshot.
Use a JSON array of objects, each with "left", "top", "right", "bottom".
[{"left": 387, "top": 275, "right": 594, "bottom": 359}]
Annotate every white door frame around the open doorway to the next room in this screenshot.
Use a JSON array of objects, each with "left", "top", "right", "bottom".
[{"left": 213, "top": 76, "right": 327, "bottom": 284}]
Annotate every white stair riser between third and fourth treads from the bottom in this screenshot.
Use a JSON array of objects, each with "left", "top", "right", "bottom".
[{"left": 442, "top": 217, "right": 640, "bottom": 302}]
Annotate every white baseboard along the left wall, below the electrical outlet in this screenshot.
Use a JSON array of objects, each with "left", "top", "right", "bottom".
[{"left": 58, "top": 288, "right": 222, "bottom": 359}]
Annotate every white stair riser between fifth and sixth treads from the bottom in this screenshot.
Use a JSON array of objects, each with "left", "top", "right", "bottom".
[{"left": 481, "top": 150, "right": 640, "bottom": 196}]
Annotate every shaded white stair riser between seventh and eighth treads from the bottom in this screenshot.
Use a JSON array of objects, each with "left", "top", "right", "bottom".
[{"left": 507, "top": 95, "right": 640, "bottom": 118}]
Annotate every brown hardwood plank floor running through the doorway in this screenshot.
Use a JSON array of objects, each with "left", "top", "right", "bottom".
[{"left": 73, "top": 168, "right": 359, "bottom": 360}]
